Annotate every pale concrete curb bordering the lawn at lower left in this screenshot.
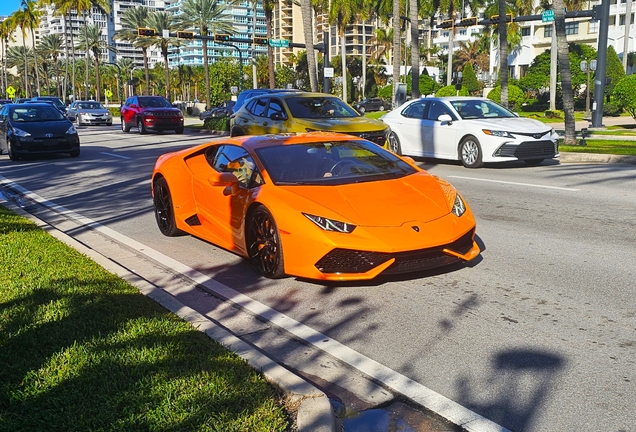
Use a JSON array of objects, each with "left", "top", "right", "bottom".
[{"left": 0, "top": 196, "right": 337, "bottom": 432}]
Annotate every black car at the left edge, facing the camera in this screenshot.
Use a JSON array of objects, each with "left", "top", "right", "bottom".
[{"left": 0, "top": 102, "right": 80, "bottom": 161}]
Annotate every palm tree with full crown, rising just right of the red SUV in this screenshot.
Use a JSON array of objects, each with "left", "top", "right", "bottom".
[{"left": 176, "top": 0, "right": 235, "bottom": 112}]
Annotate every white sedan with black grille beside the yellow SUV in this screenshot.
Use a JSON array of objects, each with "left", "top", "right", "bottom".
[{"left": 381, "top": 97, "right": 559, "bottom": 168}]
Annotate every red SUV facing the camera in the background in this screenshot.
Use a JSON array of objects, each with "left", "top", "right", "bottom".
[{"left": 120, "top": 96, "right": 183, "bottom": 134}]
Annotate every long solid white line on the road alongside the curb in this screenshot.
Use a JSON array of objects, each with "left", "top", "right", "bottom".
[{"left": 0, "top": 176, "right": 510, "bottom": 432}]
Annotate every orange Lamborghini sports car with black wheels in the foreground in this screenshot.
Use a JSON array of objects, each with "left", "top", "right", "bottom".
[{"left": 152, "top": 132, "right": 480, "bottom": 281}]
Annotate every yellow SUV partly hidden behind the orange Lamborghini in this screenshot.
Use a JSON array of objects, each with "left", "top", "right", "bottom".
[{"left": 230, "top": 92, "right": 389, "bottom": 146}]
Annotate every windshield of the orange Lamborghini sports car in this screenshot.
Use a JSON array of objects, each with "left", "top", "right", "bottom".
[{"left": 256, "top": 141, "right": 417, "bottom": 185}]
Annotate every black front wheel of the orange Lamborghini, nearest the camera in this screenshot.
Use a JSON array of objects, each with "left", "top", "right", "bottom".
[{"left": 246, "top": 206, "right": 285, "bottom": 279}]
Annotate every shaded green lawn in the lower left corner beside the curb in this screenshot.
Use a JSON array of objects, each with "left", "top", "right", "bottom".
[{"left": 0, "top": 206, "right": 290, "bottom": 432}]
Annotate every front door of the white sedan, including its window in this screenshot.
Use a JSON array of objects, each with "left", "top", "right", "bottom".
[{"left": 422, "top": 100, "right": 459, "bottom": 159}]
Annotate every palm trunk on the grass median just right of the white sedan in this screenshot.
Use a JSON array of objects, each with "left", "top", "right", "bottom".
[{"left": 553, "top": 0, "right": 577, "bottom": 145}]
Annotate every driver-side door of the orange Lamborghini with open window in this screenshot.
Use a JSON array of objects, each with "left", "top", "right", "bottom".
[{"left": 192, "top": 144, "right": 262, "bottom": 251}]
